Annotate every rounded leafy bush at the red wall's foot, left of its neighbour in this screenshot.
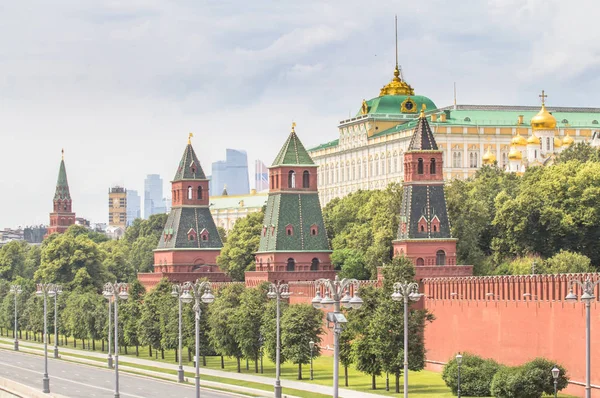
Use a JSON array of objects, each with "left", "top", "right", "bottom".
[{"left": 442, "top": 353, "right": 501, "bottom": 397}]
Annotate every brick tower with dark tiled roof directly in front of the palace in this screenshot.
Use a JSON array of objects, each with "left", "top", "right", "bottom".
[{"left": 393, "top": 110, "right": 457, "bottom": 266}]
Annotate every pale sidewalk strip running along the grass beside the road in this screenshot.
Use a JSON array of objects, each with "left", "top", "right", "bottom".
[{"left": 0, "top": 337, "right": 381, "bottom": 398}]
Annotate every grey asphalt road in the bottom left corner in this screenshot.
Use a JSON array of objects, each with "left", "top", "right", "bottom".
[{"left": 0, "top": 350, "right": 232, "bottom": 398}]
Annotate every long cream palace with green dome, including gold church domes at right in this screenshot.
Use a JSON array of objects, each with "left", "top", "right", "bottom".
[{"left": 309, "top": 66, "right": 600, "bottom": 206}]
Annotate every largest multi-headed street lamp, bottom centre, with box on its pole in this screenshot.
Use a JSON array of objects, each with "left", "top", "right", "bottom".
[{"left": 311, "top": 275, "right": 363, "bottom": 398}]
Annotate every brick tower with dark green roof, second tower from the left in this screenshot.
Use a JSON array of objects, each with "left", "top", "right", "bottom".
[{"left": 138, "top": 134, "right": 230, "bottom": 288}]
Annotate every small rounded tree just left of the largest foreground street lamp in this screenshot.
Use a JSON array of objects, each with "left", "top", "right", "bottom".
[{"left": 281, "top": 304, "right": 323, "bottom": 380}]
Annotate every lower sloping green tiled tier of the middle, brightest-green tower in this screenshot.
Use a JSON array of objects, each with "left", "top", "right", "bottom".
[{"left": 258, "top": 192, "right": 330, "bottom": 252}]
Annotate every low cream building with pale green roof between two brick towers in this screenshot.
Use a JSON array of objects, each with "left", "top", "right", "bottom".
[{"left": 210, "top": 189, "right": 268, "bottom": 232}]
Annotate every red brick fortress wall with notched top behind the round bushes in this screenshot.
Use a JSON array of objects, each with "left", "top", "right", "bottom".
[{"left": 422, "top": 274, "right": 600, "bottom": 398}]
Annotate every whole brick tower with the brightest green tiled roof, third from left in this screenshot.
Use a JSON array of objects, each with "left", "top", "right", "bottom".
[{"left": 246, "top": 124, "right": 335, "bottom": 285}]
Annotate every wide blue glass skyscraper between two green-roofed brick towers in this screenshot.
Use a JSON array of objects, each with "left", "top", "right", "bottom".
[{"left": 210, "top": 149, "right": 250, "bottom": 196}]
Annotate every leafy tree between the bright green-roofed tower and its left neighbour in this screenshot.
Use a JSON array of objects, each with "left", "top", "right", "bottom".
[{"left": 217, "top": 211, "right": 264, "bottom": 281}]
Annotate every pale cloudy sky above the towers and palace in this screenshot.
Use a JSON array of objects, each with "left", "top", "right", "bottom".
[{"left": 0, "top": 0, "right": 600, "bottom": 228}]
